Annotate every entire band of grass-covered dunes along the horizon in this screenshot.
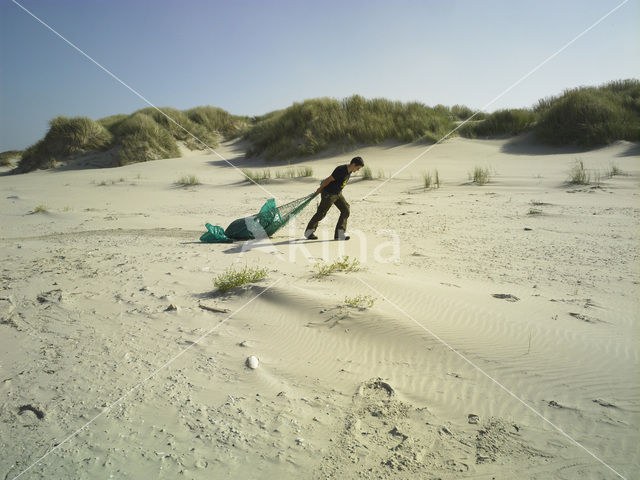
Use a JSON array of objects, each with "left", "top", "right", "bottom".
[{"left": 7, "top": 79, "right": 640, "bottom": 173}]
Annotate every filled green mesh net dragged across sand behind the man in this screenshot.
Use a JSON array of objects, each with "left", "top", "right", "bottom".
[{"left": 200, "top": 193, "right": 317, "bottom": 243}]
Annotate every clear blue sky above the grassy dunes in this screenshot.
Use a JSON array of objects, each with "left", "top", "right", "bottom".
[{"left": 0, "top": 0, "right": 640, "bottom": 151}]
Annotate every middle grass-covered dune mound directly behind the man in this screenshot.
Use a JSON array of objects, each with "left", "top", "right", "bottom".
[{"left": 244, "top": 95, "right": 454, "bottom": 160}]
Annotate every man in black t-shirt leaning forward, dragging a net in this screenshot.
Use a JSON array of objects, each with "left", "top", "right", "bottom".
[{"left": 304, "top": 157, "right": 364, "bottom": 240}]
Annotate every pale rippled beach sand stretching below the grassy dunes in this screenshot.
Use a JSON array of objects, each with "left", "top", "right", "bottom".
[{"left": 0, "top": 138, "right": 640, "bottom": 479}]
